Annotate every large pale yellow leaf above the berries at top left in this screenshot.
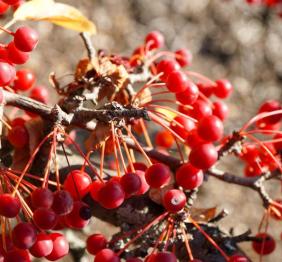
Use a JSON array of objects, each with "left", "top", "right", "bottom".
[{"left": 14, "top": 0, "right": 96, "bottom": 34}]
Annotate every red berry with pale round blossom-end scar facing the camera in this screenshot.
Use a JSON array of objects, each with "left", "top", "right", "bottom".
[{"left": 163, "top": 189, "right": 186, "bottom": 213}]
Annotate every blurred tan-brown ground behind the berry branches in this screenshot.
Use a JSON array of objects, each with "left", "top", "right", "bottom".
[{"left": 14, "top": 0, "right": 282, "bottom": 262}]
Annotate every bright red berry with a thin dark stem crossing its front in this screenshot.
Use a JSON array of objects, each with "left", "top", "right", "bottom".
[{"left": 64, "top": 170, "right": 92, "bottom": 200}]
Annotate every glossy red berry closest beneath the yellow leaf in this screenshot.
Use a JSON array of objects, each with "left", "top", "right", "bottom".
[{"left": 14, "top": 26, "right": 38, "bottom": 52}]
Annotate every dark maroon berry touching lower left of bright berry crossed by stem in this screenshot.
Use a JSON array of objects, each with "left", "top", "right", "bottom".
[{"left": 52, "top": 190, "right": 73, "bottom": 216}]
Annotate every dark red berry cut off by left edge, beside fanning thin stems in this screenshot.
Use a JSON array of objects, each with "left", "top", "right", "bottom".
[{"left": 0, "top": 193, "right": 21, "bottom": 218}]
